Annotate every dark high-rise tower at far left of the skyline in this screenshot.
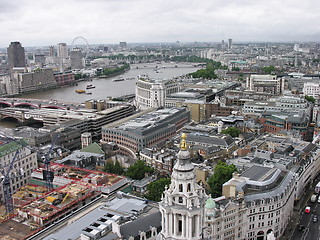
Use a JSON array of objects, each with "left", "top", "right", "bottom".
[{"left": 7, "top": 42, "right": 26, "bottom": 69}]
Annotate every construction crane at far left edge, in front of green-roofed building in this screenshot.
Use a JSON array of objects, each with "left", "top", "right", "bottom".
[{"left": 0, "top": 150, "right": 23, "bottom": 215}]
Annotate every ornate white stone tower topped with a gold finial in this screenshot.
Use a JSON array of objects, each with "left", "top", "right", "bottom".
[{"left": 158, "top": 134, "right": 208, "bottom": 240}]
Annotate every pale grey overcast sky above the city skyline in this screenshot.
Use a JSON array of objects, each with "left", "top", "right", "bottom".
[{"left": 0, "top": 0, "right": 320, "bottom": 47}]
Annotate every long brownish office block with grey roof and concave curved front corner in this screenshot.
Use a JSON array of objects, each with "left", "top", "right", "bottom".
[{"left": 102, "top": 108, "right": 190, "bottom": 156}]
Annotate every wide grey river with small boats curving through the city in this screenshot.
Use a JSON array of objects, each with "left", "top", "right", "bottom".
[{"left": 19, "top": 62, "right": 199, "bottom": 103}]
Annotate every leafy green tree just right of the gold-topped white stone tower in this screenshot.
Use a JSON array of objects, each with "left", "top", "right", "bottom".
[{"left": 208, "top": 161, "right": 237, "bottom": 197}]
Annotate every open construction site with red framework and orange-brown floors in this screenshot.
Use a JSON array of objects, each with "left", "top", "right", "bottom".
[{"left": 0, "top": 163, "right": 127, "bottom": 240}]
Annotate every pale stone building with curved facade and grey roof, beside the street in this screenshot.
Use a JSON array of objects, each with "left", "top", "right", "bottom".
[{"left": 204, "top": 166, "right": 295, "bottom": 239}]
